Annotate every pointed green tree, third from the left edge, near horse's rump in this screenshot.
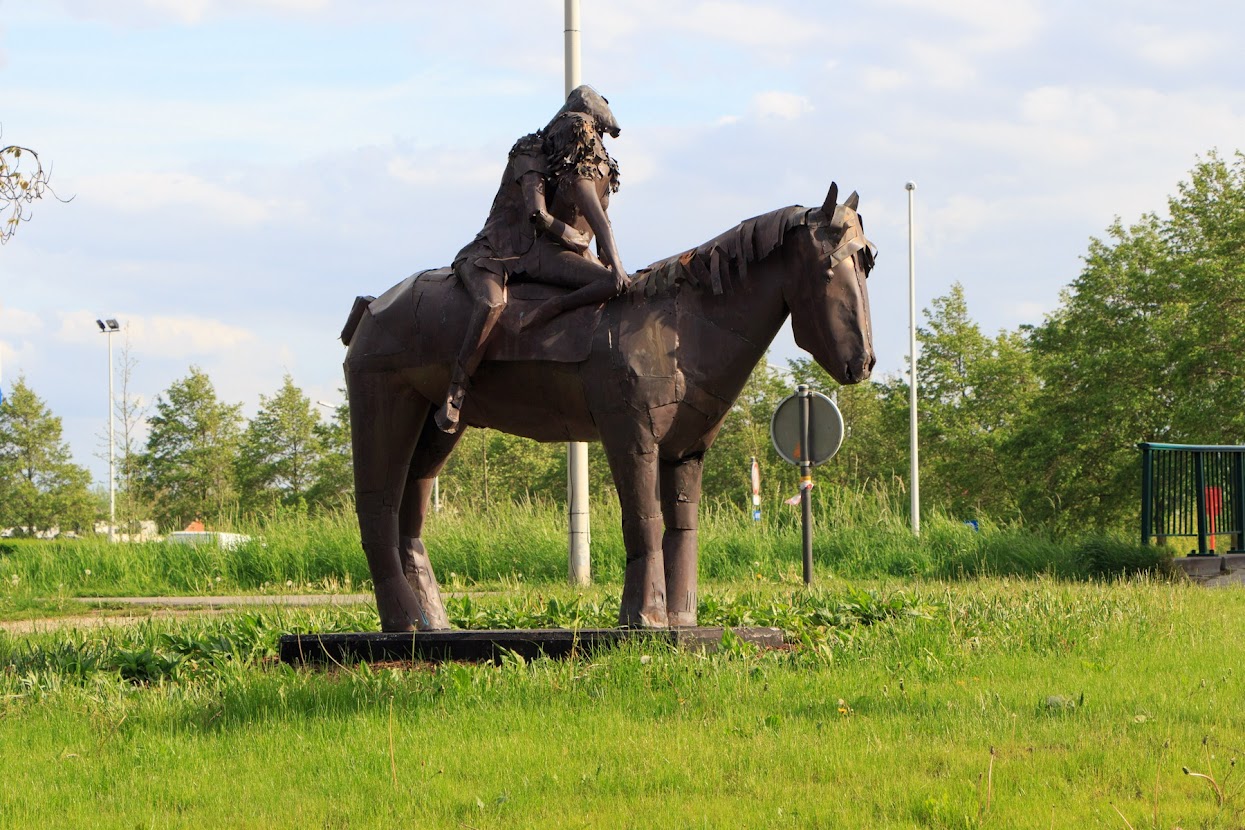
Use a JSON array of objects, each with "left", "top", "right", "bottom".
[{"left": 238, "top": 375, "right": 321, "bottom": 510}]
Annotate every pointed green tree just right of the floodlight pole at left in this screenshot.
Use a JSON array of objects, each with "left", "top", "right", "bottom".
[{"left": 142, "top": 366, "right": 242, "bottom": 529}]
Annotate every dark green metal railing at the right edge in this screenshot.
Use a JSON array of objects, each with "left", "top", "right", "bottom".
[{"left": 1137, "top": 443, "right": 1245, "bottom": 556}]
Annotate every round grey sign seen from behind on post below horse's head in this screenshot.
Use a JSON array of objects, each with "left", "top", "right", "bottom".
[{"left": 769, "top": 383, "right": 843, "bottom": 586}]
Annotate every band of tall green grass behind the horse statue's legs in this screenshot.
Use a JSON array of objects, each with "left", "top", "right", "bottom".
[{"left": 0, "top": 487, "right": 1170, "bottom": 596}]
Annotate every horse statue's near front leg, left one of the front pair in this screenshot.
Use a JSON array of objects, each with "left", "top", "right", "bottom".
[{"left": 601, "top": 429, "right": 669, "bottom": 628}]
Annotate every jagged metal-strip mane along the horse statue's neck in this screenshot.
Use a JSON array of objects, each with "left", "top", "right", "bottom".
[{"left": 627, "top": 205, "right": 809, "bottom": 297}]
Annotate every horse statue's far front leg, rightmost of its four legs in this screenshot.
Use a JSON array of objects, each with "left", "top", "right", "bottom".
[{"left": 661, "top": 457, "right": 705, "bottom": 626}]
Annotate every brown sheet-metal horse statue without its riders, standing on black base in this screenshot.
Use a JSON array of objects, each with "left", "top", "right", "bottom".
[{"left": 342, "top": 184, "right": 874, "bottom": 631}]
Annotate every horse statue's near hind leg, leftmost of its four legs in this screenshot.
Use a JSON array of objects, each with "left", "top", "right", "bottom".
[{"left": 346, "top": 368, "right": 446, "bottom": 631}]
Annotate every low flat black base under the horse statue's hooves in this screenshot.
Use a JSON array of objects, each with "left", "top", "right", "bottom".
[{"left": 280, "top": 627, "right": 782, "bottom": 663}]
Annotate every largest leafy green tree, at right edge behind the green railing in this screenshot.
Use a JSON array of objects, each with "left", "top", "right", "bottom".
[{"left": 1017, "top": 153, "right": 1245, "bottom": 529}]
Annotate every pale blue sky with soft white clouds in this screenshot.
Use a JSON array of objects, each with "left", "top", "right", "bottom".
[{"left": 0, "top": 0, "right": 1245, "bottom": 480}]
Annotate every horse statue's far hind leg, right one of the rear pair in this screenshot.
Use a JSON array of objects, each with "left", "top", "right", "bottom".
[{"left": 397, "top": 406, "right": 464, "bottom": 628}]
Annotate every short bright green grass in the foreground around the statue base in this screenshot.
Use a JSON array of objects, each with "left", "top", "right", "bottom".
[{"left": 0, "top": 576, "right": 1245, "bottom": 830}]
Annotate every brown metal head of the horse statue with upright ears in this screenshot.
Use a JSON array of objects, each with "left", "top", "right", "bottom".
[{"left": 783, "top": 184, "right": 875, "bottom": 383}]
